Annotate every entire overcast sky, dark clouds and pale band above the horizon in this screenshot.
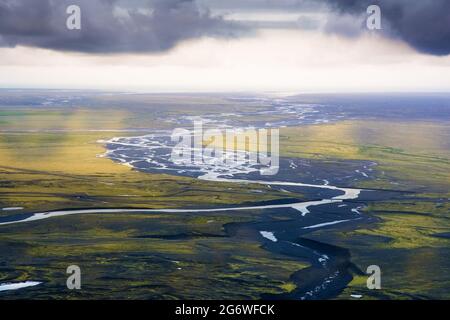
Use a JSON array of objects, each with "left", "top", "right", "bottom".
[{"left": 0, "top": 0, "right": 450, "bottom": 93}]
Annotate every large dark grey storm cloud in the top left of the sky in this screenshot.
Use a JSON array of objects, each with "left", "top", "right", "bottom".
[{"left": 0, "top": 0, "right": 243, "bottom": 53}]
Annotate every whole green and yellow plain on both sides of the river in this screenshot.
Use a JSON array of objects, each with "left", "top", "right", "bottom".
[{"left": 0, "top": 95, "right": 450, "bottom": 299}]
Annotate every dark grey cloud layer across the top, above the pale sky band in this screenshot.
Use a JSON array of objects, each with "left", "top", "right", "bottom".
[{"left": 0, "top": 0, "right": 450, "bottom": 56}]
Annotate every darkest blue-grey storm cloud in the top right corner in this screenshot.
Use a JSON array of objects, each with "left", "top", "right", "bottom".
[{"left": 325, "top": 0, "right": 450, "bottom": 56}]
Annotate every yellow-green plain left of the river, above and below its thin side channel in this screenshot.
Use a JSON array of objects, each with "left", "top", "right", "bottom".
[{"left": 0, "top": 96, "right": 306, "bottom": 299}]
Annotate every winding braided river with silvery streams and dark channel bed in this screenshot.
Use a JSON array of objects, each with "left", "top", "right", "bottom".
[{"left": 0, "top": 99, "right": 400, "bottom": 299}]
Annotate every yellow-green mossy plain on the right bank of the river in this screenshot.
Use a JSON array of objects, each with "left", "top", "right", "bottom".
[{"left": 282, "top": 121, "right": 450, "bottom": 299}]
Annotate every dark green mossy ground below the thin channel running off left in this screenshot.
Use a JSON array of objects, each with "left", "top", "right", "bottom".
[{"left": 1, "top": 213, "right": 303, "bottom": 299}]
